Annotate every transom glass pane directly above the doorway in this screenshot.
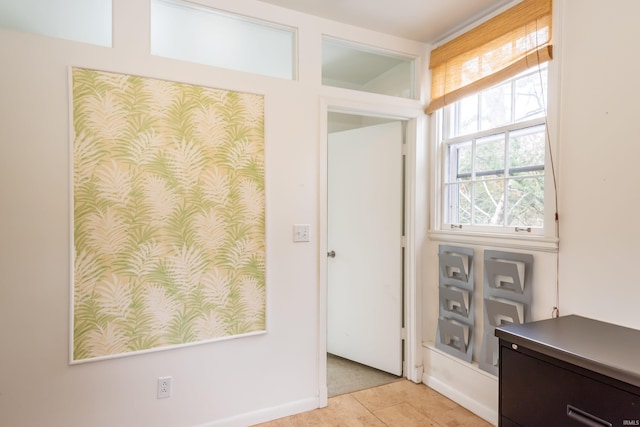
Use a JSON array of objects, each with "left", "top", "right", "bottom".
[{"left": 322, "top": 38, "right": 415, "bottom": 98}]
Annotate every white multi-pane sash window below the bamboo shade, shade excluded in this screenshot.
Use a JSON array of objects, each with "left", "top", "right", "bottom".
[{"left": 440, "top": 64, "right": 548, "bottom": 235}]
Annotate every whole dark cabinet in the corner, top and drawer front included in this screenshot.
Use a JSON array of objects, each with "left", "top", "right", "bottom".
[{"left": 496, "top": 316, "right": 640, "bottom": 427}]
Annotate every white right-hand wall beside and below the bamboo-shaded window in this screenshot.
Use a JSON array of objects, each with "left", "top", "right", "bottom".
[{"left": 423, "top": 0, "right": 640, "bottom": 422}]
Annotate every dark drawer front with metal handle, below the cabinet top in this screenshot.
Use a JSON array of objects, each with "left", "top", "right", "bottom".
[{"left": 500, "top": 346, "right": 640, "bottom": 427}]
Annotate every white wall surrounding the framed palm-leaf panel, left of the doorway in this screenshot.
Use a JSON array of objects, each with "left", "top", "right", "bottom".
[{"left": 0, "top": 0, "right": 425, "bottom": 427}]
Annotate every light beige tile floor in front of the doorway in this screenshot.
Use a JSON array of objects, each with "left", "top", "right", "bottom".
[{"left": 252, "top": 380, "right": 491, "bottom": 427}]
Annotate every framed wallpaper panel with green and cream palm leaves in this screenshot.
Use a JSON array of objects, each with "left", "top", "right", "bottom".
[{"left": 71, "top": 68, "right": 266, "bottom": 361}]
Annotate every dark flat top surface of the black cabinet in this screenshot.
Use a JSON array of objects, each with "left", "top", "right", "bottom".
[{"left": 495, "top": 315, "right": 640, "bottom": 387}]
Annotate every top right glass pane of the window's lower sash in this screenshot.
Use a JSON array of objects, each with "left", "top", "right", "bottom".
[{"left": 509, "top": 126, "right": 545, "bottom": 176}]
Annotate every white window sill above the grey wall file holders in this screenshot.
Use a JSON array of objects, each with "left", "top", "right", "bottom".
[{"left": 428, "top": 230, "right": 559, "bottom": 253}]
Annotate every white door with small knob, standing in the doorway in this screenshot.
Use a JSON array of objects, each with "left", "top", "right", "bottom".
[{"left": 327, "top": 122, "right": 403, "bottom": 375}]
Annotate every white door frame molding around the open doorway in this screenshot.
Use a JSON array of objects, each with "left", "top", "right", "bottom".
[{"left": 318, "top": 97, "right": 427, "bottom": 407}]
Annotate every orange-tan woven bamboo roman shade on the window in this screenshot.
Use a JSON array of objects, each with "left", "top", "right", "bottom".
[{"left": 425, "top": 0, "right": 552, "bottom": 114}]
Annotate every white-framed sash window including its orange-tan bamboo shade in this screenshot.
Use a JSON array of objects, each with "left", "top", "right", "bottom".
[{"left": 425, "top": 0, "right": 555, "bottom": 237}]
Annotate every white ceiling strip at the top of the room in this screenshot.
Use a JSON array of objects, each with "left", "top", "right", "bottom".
[{"left": 261, "top": 0, "right": 513, "bottom": 43}]
